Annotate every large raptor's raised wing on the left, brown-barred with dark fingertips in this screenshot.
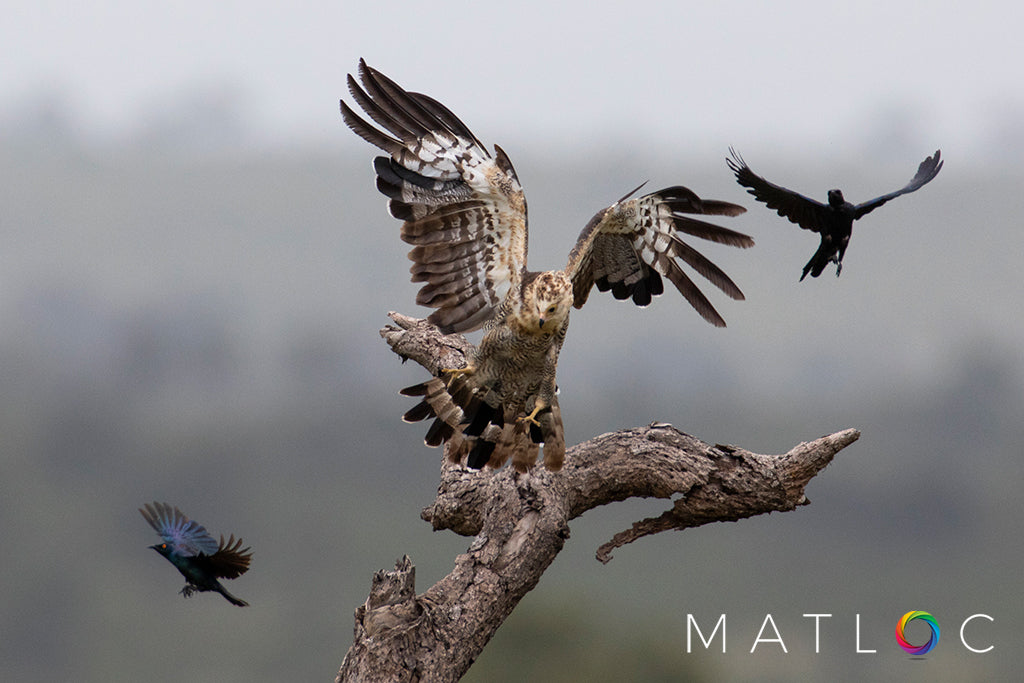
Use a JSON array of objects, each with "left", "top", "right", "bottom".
[{"left": 341, "top": 59, "right": 526, "bottom": 334}]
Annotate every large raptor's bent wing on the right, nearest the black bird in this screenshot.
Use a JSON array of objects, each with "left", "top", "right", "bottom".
[{"left": 565, "top": 186, "right": 754, "bottom": 327}]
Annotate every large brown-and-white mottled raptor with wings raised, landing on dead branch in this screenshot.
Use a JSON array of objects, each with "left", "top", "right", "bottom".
[{"left": 341, "top": 59, "right": 754, "bottom": 472}]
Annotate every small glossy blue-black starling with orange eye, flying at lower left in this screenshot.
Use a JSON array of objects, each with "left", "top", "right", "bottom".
[{"left": 138, "top": 503, "right": 252, "bottom": 607}]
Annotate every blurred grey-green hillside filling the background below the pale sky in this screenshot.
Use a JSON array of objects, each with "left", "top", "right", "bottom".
[{"left": 0, "top": 124, "right": 1024, "bottom": 681}]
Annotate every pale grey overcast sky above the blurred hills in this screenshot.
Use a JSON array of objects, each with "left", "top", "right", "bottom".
[{"left": 0, "top": 0, "right": 1024, "bottom": 158}]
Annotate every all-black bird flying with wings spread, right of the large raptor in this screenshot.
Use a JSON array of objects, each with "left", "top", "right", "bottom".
[{"left": 725, "top": 147, "right": 942, "bottom": 281}]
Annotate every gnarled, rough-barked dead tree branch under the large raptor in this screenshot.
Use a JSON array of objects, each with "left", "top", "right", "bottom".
[{"left": 337, "top": 312, "right": 860, "bottom": 683}]
